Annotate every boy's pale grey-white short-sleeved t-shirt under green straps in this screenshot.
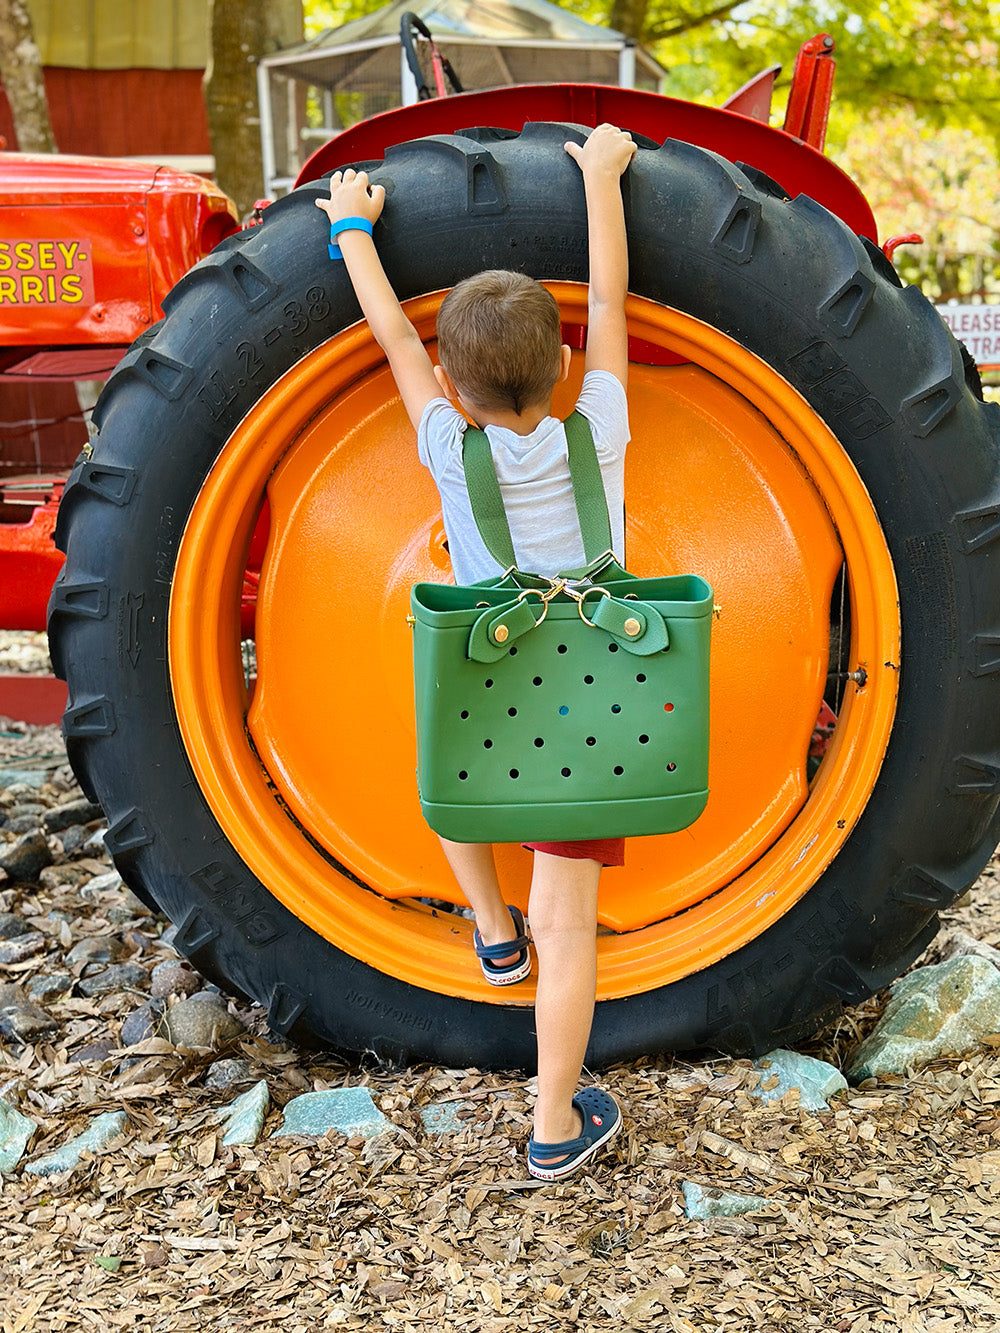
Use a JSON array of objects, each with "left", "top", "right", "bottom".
[{"left": 417, "top": 371, "right": 629, "bottom": 584}]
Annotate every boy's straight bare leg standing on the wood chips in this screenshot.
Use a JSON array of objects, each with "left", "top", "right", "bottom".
[{"left": 529, "top": 852, "right": 603, "bottom": 1165}]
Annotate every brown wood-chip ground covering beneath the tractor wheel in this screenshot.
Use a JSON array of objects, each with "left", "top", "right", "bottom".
[{"left": 0, "top": 709, "right": 1000, "bottom": 1333}]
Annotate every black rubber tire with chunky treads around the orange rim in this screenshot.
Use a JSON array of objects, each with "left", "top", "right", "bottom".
[{"left": 49, "top": 124, "right": 1000, "bottom": 1069}]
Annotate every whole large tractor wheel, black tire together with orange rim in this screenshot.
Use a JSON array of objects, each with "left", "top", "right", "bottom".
[{"left": 49, "top": 124, "right": 1000, "bottom": 1068}]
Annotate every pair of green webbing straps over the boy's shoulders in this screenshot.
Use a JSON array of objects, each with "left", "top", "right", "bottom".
[{"left": 461, "top": 412, "right": 611, "bottom": 569}]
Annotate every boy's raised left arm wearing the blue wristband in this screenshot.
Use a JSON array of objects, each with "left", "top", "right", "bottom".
[{"left": 316, "top": 169, "right": 441, "bottom": 429}]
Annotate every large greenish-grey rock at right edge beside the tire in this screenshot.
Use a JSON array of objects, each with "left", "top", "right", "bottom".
[{"left": 844, "top": 954, "right": 1000, "bottom": 1082}]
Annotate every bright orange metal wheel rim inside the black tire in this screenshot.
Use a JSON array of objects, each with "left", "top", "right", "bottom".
[{"left": 169, "top": 283, "right": 900, "bottom": 1005}]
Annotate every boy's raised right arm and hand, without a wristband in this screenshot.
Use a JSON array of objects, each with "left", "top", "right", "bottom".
[{"left": 565, "top": 125, "right": 636, "bottom": 385}]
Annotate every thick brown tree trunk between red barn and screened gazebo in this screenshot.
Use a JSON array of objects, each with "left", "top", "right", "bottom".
[{"left": 204, "top": 0, "right": 303, "bottom": 217}]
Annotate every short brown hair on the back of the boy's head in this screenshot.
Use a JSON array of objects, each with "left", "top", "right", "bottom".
[{"left": 437, "top": 268, "right": 563, "bottom": 413}]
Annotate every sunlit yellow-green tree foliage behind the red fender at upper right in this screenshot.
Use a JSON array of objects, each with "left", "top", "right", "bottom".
[{"left": 305, "top": 0, "right": 1000, "bottom": 299}]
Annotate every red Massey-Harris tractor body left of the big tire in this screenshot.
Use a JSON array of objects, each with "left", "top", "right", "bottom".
[{"left": 0, "top": 153, "right": 239, "bottom": 647}]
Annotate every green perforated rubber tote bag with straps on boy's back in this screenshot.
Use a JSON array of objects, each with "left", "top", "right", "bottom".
[{"left": 409, "top": 412, "right": 713, "bottom": 842}]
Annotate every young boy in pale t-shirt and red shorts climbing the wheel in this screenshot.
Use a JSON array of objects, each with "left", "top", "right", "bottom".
[{"left": 316, "top": 125, "right": 636, "bottom": 1180}]
